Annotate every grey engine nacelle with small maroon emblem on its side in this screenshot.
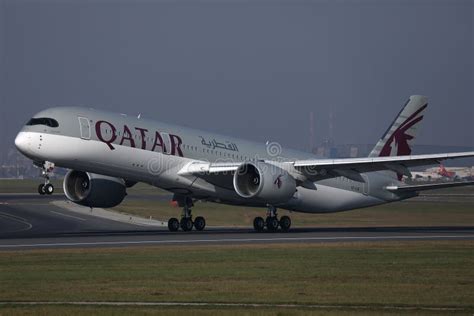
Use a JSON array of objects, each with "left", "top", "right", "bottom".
[{"left": 234, "top": 162, "right": 296, "bottom": 204}]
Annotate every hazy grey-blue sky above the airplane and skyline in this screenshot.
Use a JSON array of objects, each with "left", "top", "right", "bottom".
[{"left": 0, "top": 0, "right": 474, "bottom": 154}]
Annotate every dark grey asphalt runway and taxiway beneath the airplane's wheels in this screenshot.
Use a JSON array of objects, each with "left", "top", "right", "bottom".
[{"left": 0, "top": 194, "right": 474, "bottom": 251}]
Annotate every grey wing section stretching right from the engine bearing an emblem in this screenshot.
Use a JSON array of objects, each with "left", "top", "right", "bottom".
[{"left": 293, "top": 151, "right": 474, "bottom": 181}]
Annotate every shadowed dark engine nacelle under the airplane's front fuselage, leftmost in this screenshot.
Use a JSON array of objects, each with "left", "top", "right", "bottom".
[{"left": 63, "top": 170, "right": 127, "bottom": 208}]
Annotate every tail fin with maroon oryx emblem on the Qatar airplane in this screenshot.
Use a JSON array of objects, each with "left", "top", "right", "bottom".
[{"left": 369, "top": 95, "right": 428, "bottom": 157}]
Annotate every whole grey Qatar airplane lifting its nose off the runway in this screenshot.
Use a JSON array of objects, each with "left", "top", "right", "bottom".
[{"left": 15, "top": 95, "right": 474, "bottom": 232}]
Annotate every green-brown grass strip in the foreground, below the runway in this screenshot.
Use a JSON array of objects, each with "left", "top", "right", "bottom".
[{"left": 0, "top": 241, "right": 474, "bottom": 314}]
